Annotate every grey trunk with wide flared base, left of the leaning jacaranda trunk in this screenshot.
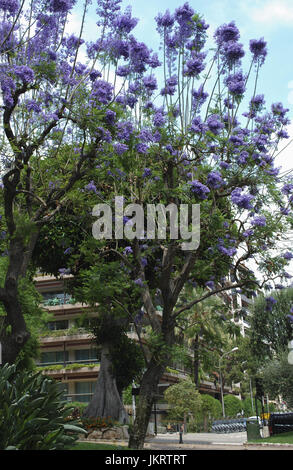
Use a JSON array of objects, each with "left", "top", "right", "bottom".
[{"left": 83, "top": 343, "right": 128, "bottom": 424}]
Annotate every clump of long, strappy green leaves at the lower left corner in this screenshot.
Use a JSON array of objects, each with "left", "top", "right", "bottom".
[{"left": 0, "top": 364, "right": 87, "bottom": 450}]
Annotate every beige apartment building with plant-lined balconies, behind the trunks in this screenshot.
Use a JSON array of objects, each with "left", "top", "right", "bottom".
[{"left": 35, "top": 275, "right": 192, "bottom": 403}]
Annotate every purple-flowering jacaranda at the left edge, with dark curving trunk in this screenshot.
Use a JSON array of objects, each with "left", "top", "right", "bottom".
[{"left": 0, "top": 0, "right": 147, "bottom": 363}]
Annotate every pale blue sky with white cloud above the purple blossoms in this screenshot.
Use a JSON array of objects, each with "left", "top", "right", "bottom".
[{"left": 69, "top": 0, "right": 293, "bottom": 280}]
